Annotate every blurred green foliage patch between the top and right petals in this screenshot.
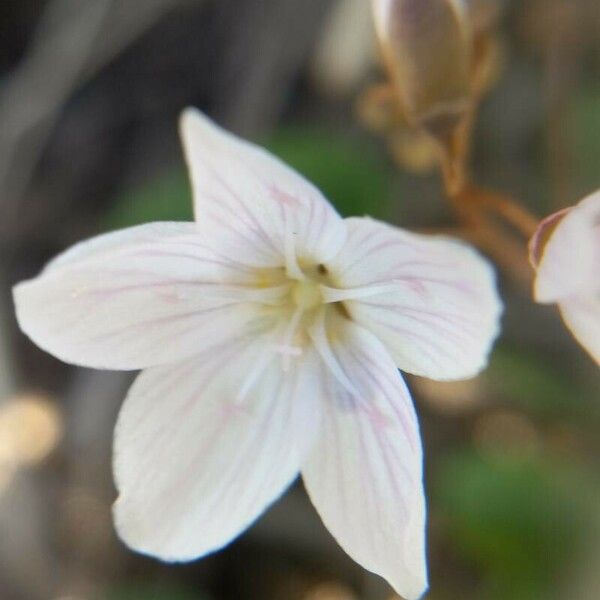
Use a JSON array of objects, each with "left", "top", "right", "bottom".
[{"left": 266, "top": 127, "right": 390, "bottom": 218}]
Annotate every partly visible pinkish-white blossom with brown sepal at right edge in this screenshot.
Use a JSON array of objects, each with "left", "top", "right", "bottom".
[{"left": 529, "top": 191, "right": 600, "bottom": 364}]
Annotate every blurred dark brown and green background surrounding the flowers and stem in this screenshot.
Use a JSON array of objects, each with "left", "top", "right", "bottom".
[{"left": 0, "top": 0, "right": 600, "bottom": 600}]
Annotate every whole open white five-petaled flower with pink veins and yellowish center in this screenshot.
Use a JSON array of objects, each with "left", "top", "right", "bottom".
[{"left": 14, "top": 109, "right": 501, "bottom": 599}]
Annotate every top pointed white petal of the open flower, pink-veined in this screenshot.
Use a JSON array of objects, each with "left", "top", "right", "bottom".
[{"left": 181, "top": 109, "right": 345, "bottom": 267}]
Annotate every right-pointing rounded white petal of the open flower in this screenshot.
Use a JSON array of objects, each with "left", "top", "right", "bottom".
[{"left": 327, "top": 219, "right": 501, "bottom": 380}]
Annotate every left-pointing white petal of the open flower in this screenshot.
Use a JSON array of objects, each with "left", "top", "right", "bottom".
[{"left": 14, "top": 223, "right": 274, "bottom": 369}]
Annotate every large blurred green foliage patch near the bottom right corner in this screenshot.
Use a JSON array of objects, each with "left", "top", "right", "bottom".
[{"left": 433, "top": 450, "right": 594, "bottom": 600}]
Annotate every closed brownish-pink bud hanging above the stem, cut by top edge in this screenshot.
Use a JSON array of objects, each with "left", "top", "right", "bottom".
[{"left": 373, "top": 0, "right": 472, "bottom": 142}]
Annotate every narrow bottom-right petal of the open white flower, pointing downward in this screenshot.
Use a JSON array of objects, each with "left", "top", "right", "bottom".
[{"left": 302, "top": 321, "right": 427, "bottom": 600}]
